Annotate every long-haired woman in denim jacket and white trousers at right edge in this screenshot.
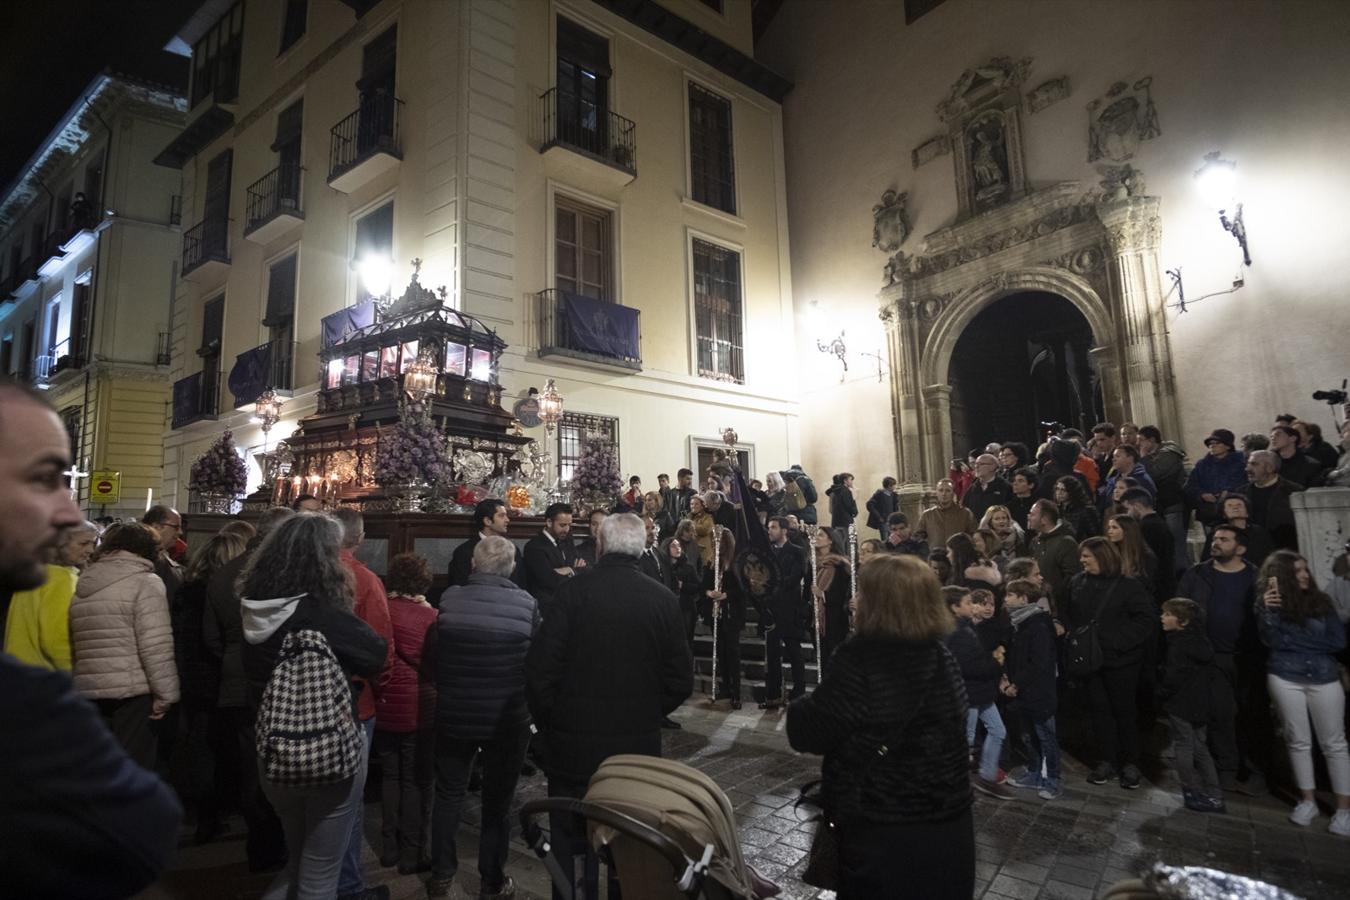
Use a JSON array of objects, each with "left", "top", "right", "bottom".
[{"left": 1257, "top": 551, "right": 1350, "bottom": 837}]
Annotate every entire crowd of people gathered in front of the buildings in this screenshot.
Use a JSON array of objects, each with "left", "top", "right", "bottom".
[{"left": 0, "top": 372, "right": 1350, "bottom": 900}]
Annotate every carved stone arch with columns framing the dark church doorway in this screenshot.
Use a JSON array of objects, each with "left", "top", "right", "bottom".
[{"left": 879, "top": 182, "right": 1180, "bottom": 507}]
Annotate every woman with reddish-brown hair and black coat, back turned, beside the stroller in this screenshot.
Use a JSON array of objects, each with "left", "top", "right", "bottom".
[{"left": 787, "top": 555, "right": 975, "bottom": 900}]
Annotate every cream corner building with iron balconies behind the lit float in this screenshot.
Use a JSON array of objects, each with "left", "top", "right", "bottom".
[{"left": 158, "top": 0, "right": 797, "bottom": 507}]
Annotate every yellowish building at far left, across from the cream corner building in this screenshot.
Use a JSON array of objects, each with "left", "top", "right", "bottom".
[{"left": 0, "top": 66, "right": 186, "bottom": 515}]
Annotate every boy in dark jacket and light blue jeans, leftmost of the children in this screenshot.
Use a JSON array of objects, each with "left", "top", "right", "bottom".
[{"left": 942, "top": 587, "right": 1013, "bottom": 800}]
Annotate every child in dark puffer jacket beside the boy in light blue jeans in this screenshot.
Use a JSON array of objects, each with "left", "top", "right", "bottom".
[{"left": 1000, "top": 579, "right": 1062, "bottom": 800}]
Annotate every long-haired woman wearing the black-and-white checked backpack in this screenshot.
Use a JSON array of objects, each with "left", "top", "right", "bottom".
[{"left": 239, "top": 513, "right": 387, "bottom": 900}]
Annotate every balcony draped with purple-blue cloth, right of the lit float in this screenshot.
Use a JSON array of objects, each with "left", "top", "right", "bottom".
[{"left": 536, "top": 290, "right": 643, "bottom": 372}]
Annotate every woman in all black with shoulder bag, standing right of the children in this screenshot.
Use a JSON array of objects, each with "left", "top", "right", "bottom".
[{"left": 1060, "top": 537, "right": 1157, "bottom": 791}]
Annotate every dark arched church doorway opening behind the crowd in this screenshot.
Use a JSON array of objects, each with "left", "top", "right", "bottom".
[{"left": 948, "top": 291, "right": 1104, "bottom": 456}]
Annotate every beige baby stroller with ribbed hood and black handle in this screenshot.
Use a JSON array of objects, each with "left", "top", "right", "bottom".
[{"left": 520, "top": 754, "right": 780, "bottom": 900}]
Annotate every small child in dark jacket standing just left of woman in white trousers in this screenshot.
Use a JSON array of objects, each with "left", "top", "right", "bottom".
[{"left": 1158, "top": 598, "right": 1231, "bottom": 812}]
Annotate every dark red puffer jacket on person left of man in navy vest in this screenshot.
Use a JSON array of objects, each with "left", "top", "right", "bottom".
[{"left": 375, "top": 594, "right": 436, "bottom": 731}]
